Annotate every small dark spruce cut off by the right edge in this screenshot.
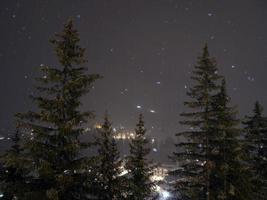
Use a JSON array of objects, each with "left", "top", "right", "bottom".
[{"left": 243, "top": 101, "right": 267, "bottom": 200}]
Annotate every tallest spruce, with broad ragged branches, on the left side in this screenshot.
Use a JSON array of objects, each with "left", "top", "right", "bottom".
[{"left": 17, "top": 20, "right": 100, "bottom": 200}]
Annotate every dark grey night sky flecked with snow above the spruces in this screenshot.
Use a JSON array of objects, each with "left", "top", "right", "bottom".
[{"left": 0, "top": 0, "right": 267, "bottom": 141}]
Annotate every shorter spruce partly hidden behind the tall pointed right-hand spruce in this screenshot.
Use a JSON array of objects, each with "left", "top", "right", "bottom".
[{"left": 210, "top": 80, "right": 252, "bottom": 200}]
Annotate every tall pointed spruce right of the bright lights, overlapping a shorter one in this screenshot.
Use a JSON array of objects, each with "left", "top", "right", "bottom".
[{"left": 173, "top": 44, "right": 221, "bottom": 200}]
